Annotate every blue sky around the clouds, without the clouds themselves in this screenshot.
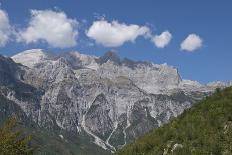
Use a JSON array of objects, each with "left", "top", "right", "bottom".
[{"left": 0, "top": 0, "right": 232, "bottom": 83}]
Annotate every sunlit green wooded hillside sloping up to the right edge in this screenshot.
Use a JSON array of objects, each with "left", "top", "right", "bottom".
[{"left": 117, "top": 87, "right": 232, "bottom": 155}]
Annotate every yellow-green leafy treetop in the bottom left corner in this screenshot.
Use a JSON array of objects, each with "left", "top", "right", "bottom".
[{"left": 0, "top": 117, "right": 33, "bottom": 155}]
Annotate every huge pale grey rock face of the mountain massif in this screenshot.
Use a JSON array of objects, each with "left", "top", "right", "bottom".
[{"left": 0, "top": 49, "right": 228, "bottom": 152}]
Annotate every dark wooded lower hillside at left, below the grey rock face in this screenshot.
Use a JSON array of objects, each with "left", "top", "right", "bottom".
[{"left": 0, "top": 92, "right": 109, "bottom": 155}]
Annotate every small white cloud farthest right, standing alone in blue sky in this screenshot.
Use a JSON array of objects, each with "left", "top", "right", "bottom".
[{"left": 180, "top": 34, "right": 203, "bottom": 52}]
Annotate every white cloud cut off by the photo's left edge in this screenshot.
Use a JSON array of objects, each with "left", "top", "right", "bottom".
[{"left": 0, "top": 9, "right": 11, "bottom": 47}]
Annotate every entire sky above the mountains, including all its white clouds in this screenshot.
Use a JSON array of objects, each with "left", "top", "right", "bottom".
[{"left": 0, "top": 0, "right": 232, "bottom": 83}]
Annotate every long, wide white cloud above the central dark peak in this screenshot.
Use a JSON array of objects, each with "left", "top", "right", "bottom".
[{"left": 86, "top": 19, "right": 150, "bottom": 47}]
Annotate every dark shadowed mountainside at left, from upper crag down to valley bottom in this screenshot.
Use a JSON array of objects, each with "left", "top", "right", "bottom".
[{"left": 0, "top": 53, "right": 109, "bottom": 155}]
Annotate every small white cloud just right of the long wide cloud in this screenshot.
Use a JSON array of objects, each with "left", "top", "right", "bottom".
[{"left": 151, "top": 31, "right": 172, "bottom": 48}]
